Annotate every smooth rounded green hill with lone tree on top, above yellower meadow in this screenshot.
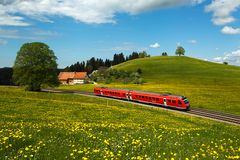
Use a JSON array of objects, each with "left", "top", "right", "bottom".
[{"left": 114, "top": 56, "right": 240, "bottom": 85}]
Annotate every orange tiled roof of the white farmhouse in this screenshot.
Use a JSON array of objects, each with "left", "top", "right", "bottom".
[{"left": 58, "top": 72, "right": 87, "bottom": 80}]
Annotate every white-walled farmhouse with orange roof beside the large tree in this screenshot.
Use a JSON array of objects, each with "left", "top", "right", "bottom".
[{"left": 58, "top": 72, "right": 88, "bottom": 85}]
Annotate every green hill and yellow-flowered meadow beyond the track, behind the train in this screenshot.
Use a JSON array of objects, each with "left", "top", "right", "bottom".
[{"left": 60, "top": 56, "right": 240, "bottom": 115}]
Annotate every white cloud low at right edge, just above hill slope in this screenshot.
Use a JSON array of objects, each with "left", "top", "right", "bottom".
[{"left": 213, "top": 49, "right": 240, "bottom": 66}]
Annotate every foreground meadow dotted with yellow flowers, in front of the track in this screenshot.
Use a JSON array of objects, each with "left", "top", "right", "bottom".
[{"left": 0, "top": 87, "right": 240, "bottom": 160}]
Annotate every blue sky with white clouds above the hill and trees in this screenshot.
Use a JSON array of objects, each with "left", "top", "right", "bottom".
[{"left": 0, "top": 0, "right": 240, "bottom": 68}]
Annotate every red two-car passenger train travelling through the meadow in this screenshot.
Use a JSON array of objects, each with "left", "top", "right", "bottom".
[{"left": 94, "top": 87, "right": 190, "bottom": 110}]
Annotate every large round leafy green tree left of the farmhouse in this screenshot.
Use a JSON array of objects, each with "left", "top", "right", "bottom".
[{"left": 13, "top": 42, "right": 59, "bottom": 91}]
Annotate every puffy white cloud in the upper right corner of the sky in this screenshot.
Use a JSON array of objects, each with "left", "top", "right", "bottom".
[{"left": 205, "top": 0, "right": 240, "bottom": 25}]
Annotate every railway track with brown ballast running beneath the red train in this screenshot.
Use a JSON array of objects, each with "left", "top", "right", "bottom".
[{"left": 42, "top": 89, "right": 240, "bottom": 125}]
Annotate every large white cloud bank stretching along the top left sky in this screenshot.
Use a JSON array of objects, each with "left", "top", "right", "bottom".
[{"left": 0, "top": 0, "right": 203, "bottom": 26}]
